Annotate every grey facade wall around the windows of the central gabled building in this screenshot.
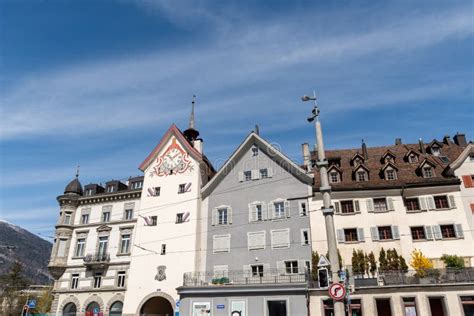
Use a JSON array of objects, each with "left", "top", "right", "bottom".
[{"left": 206, "top": 146, "right": 311, "bottom": 272}]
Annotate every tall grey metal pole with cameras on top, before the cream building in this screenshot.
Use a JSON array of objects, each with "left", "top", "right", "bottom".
[{"left": 301, "top": 91, "right": 344, "bottom": 316}]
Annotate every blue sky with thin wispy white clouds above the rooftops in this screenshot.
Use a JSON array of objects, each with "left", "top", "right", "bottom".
[{"left": 0, "top": 0, "right": 474, "bottom": 239}]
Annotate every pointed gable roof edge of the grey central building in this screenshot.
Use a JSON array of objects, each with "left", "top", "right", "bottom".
[{"left": 201, "top": 132, "right": 313, "bottom": 198}]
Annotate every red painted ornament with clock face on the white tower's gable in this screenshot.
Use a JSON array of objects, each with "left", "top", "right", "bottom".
[{"left": 150, "top": 138, "right": 192, "bottom": 177}]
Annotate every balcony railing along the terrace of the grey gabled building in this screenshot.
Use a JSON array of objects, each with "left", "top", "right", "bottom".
[{"left": 183, "top": 268, "right": 309, "bottom": 286}]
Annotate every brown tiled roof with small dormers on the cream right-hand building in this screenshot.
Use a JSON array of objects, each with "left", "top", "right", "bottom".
[{"left": 312, "top": 140, "right": 464, "bottom": 191}]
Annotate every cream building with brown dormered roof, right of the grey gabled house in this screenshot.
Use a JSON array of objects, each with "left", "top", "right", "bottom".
[{"left": 310, "top": 135, "right": 474, "bottom": 315}]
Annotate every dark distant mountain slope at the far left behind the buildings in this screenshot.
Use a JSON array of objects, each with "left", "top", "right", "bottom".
[{"left": 0, "top": 220, "right": 53, "bottom": 284}]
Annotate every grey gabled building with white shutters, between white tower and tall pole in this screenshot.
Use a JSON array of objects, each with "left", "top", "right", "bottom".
[{"left": 178, "top": 133, "right": 313, "bottom": 316}]
